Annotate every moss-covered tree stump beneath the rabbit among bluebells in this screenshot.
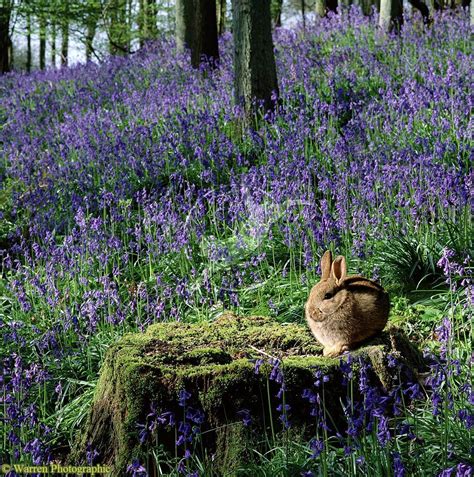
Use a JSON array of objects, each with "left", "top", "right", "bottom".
[{"left": 73, "top": 314, "right": 422, "bottom": 475}]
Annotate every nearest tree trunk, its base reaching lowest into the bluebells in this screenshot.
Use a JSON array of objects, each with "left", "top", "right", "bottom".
[{"left": 232, "top": 0, "right": 278, "bottom": 112}]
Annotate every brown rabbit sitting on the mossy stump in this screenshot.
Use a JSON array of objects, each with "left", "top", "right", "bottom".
[{"left": 305, "top": 250, "right": 390, "bottom": 357}]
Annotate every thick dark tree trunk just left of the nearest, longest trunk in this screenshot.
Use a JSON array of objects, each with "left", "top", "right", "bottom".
[{"left": 176, "top": 0, "right": 219, "bottom": 68}]
